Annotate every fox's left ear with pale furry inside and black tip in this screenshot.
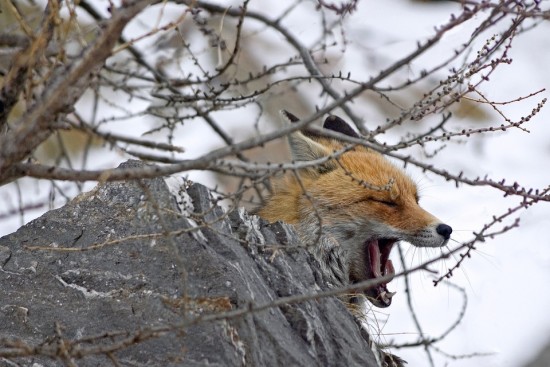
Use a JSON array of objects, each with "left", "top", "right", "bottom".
[{"left": 281, "top": 110, "right": 336, "bottom": 173}]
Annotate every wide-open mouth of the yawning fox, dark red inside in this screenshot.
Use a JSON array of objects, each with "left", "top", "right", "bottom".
[{"left": 358, "top": 238, "right": 397, "bottom": 307}]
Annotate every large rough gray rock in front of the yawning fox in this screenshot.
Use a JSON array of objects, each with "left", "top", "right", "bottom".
[{"left": 0, "top": 162, "right": 376, "bottom": 367}]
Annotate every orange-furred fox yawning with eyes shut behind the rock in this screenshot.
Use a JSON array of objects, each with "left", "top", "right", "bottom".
[{"left": 258, "top": 111, "right": 452, "bottom": 307}]
